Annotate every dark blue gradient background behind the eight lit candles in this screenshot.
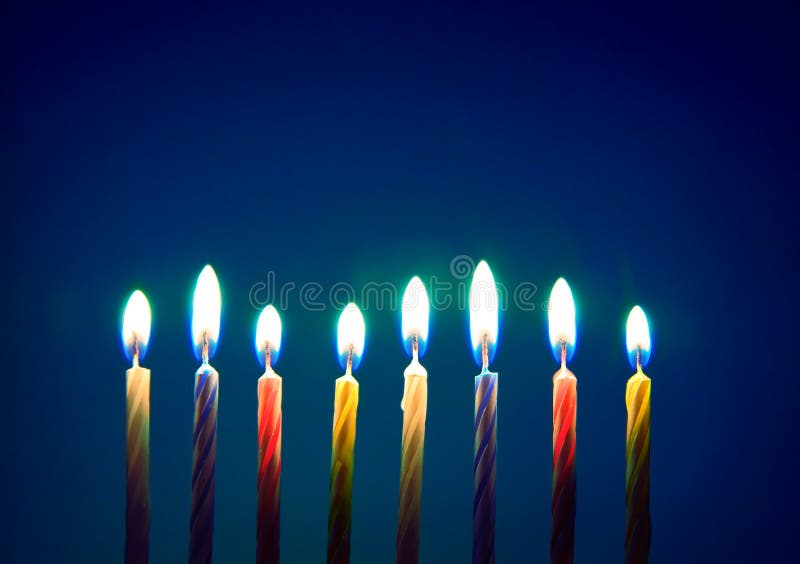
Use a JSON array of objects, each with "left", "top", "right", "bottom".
[{"left": 0, "top": 3, "right": 800, "bottom": 563}]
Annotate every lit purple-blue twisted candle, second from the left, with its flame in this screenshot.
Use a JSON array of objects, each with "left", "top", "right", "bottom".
[{"left": 189, "top": 265, "right": 222, "bottom": 564}]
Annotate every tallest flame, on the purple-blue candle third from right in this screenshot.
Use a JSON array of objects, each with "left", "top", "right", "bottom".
[{"left": 469, "top": 260, "right": 500, "bottom": 366}]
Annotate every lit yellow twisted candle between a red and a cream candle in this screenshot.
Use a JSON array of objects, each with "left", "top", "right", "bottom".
[{"left": 328, "top": 303, "right": 366, "bottom": 563}]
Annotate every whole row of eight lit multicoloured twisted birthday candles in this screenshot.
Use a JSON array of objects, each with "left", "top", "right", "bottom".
[{"left": 122, "top": 261, "right": 651, "bottom": 564}]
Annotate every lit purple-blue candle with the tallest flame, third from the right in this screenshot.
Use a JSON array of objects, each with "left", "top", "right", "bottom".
[{"left": 469, "top": 260, "right": 499, "bottom": 564}]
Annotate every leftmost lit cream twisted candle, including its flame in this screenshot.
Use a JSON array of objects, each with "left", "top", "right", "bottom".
[{"left": 122, "top": 290, "right": 150, "bottom": 564}]
